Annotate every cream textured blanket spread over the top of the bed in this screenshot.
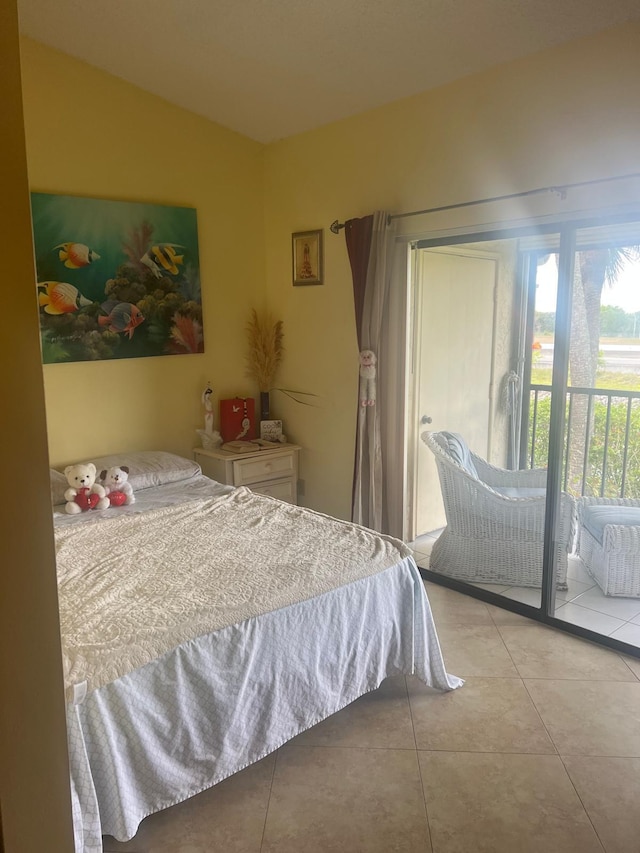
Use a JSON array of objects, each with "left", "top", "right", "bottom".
[{"left": 56, "top": 488, "right": 410, "bottom": 699}]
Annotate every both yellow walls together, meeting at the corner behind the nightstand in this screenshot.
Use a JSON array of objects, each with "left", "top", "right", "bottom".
[{"left": 17, "top": 26, "right": 640, "bottom": 517}]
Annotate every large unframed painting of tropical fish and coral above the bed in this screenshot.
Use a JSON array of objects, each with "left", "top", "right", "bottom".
[{"left": 31, "top": 193, "right": 204, "bottom": 364}]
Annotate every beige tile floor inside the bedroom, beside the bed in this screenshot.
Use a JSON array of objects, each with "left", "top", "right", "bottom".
[{"left": 104, "top": 572, "right": 640, "bottom": 853}]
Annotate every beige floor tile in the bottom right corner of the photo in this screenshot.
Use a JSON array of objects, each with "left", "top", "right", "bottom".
[{"left": 563, "top": 755, "right": 640, "bottom": 853}]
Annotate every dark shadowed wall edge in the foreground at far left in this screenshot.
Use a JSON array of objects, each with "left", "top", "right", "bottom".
[{"left": 0, "top": 2, "right": 73, "bottom": 853}]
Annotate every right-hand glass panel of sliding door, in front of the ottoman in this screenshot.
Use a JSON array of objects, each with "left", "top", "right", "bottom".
[{"left": 530, "top": 222, "right": 640, "bottom": 647}]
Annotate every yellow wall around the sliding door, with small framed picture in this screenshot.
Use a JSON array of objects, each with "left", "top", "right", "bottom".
[{"left": 265, "top": 25, "right": 640, "bottom": 517}]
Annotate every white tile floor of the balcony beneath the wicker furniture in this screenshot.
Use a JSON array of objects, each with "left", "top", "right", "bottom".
[{"left": 411, "top": 532, "right": 640, "bottom": 644}]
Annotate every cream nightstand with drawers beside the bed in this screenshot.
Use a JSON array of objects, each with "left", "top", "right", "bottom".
[{"left": 193, "top": 444, "right": 300, "bottom": 504}]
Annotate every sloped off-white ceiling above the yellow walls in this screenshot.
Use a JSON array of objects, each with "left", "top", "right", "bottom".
[{"left": 18, "top": 0, "right": 640, "bottom": 142}]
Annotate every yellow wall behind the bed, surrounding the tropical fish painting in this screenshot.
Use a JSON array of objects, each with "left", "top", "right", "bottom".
[{"left": 22, "top": 39, "right": 264, "bottom": 465}]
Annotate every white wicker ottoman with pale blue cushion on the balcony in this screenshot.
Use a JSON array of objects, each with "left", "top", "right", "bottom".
[{"left": 577, "top": 498, "right": 640, "bottom": 598}]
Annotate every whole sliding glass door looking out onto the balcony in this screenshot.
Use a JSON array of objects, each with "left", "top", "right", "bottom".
[{"left": 414, "top": 210, "right": 640, "bottom": 648}]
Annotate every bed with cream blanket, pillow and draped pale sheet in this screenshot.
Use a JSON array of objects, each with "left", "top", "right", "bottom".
[{"left": 51, "top": 452, "right": 462, "bottom": 853}]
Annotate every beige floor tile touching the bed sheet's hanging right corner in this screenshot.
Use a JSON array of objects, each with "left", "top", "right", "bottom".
[{"left": 407, "top": 677, "right": 556, "bottom": 753}]
